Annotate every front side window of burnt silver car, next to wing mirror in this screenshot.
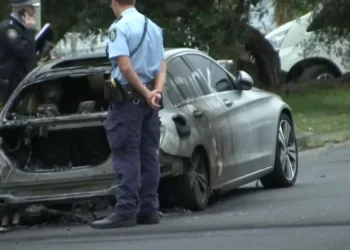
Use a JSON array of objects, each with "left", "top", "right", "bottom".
[{"left": 185, "top": 54, "right": 234, "bottom": 93}]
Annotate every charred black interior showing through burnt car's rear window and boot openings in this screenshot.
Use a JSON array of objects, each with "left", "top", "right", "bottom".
[{"left": 1, "top": 74, "right": 110, "bottom": 172}]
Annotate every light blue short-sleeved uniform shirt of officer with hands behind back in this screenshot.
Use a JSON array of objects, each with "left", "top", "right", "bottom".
[{"left": 107, "top": 8, "right": 165, "bottom": 84}]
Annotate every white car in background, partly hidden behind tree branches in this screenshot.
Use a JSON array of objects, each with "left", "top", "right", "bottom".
[{"left": 266, "top": 12, "right": 349, "bottom": 82}]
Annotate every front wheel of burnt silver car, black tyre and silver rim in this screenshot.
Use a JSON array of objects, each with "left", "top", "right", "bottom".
[{"left": 261, "top": 113, "right": 299, "bottom": 188}]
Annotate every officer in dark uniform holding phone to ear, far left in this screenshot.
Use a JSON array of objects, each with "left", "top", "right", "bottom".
[{"left": 0, "top": 0, "right": 38, "bottom": 103}]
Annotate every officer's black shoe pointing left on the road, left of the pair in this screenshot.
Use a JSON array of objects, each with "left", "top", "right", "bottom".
[{"left": 91, "top": 213, "right": 137, "bottom": 229}]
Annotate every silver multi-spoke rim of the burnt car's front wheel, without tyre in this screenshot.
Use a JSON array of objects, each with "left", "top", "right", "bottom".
[{"left": 278, "top": 120, "right": 297, "bottom": 181}]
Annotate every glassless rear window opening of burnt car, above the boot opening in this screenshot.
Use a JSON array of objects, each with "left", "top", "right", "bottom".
[{"left": 8, "top": 74, "right": 108, "bottom": 116}]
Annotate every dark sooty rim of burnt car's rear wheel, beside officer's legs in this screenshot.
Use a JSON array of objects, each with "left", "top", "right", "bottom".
[{"left": 190, "top": 153, "right": 208, "bottom": 204}]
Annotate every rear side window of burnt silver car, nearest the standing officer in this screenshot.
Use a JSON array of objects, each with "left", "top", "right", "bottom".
[{"left": 168, "top": 57, "right": 205, "bottom": 101}]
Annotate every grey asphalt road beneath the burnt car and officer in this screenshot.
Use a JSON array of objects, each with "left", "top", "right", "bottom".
[{"left": 0, "top": 143, "right": 350, "bottom": 250}]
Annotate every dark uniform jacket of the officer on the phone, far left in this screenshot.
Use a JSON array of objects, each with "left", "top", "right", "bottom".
[{"left": 0, "top": 16, "right": 37, "bottom": 102}]
